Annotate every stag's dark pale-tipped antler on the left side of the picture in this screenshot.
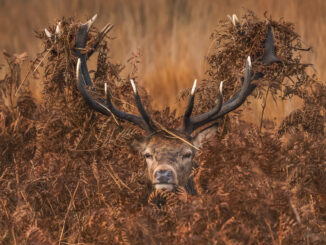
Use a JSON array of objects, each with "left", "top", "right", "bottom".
[{"left": 76, "top": 15, "right": 156, "bottom": 132}]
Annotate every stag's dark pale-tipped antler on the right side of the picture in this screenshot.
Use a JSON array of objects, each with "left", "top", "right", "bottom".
[{"left": 182, "top": 23, "right": 280, "bottom": 135}]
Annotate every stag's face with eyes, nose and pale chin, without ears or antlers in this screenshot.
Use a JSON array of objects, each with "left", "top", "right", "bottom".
[{"left": 135, "top": 135, "right": 196, "bottom": 191}]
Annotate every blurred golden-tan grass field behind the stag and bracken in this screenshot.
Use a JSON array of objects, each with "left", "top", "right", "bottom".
[{"left": 0, "top": 0, "right": 326, "bottom": 122}]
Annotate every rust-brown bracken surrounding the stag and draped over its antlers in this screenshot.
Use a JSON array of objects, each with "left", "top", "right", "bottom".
[{"left": 0, "top": 13, "right": 326, "bottom": 244}]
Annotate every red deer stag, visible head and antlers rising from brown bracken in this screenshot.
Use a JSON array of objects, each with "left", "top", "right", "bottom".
[{"left": 76, "top": 16, "right": 279, "bottom": 194}]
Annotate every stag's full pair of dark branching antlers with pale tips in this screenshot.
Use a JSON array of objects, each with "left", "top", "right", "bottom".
[{"left": 76, "top": 15, "right": 280, "bottom": 135}]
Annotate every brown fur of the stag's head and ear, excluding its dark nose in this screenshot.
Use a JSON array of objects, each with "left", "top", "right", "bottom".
[{"left": 133, "top": 127, "right": 215, "bottom": 194}]
